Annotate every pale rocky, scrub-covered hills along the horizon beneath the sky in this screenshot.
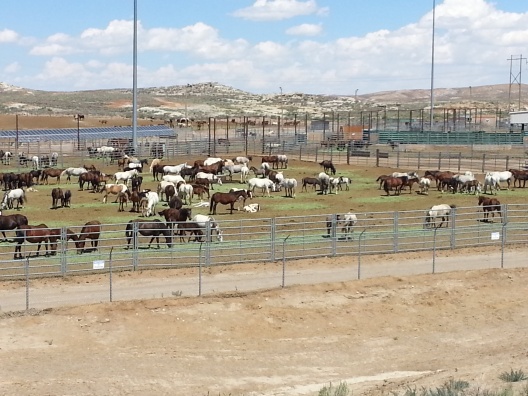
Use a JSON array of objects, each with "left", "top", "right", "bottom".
[{"left": 0, "top": 82, "right": 528, "bottom": 119}]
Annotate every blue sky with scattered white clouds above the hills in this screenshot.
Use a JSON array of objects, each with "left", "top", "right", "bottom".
[{"left": 0, "top": 0, "right": 528, "bottom": 95}]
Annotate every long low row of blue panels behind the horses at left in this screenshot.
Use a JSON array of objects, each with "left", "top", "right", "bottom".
[{"left": 0, "top": 125, "right": 174, "bottom": 142}]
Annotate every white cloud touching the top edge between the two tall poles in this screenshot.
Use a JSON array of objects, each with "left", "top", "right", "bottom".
[{"left": 233, "top": 0, "right": 327, "bottom": 21}]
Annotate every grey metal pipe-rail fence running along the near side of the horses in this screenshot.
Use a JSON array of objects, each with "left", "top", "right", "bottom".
[{"left": 0, "top": 205, "right": 528, "bottom": 311}]
